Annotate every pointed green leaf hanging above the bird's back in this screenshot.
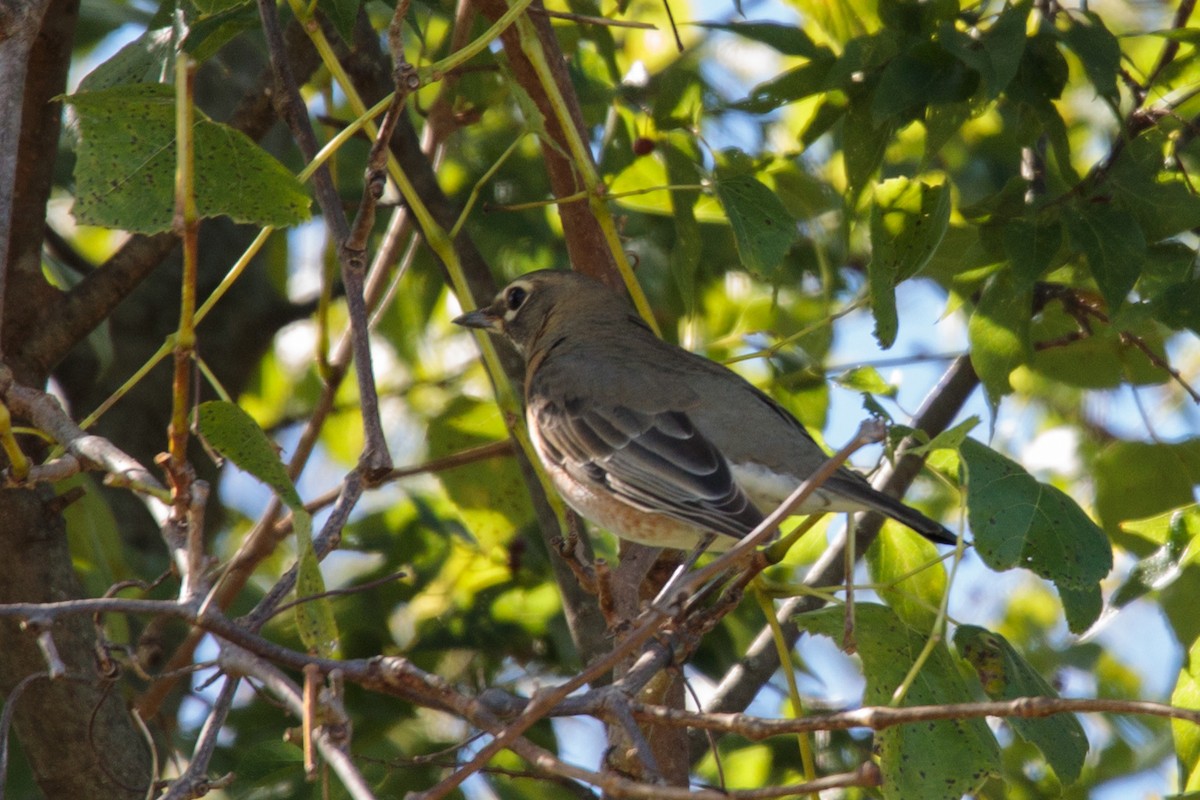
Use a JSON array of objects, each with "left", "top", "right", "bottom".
[{"left": 714, "top": 172, "right": 799, "bottom": 283}]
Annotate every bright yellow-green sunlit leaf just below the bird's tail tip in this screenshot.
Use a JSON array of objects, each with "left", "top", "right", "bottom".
[{"left": 866, "top": 524, "right": 946, "bottom": 631}]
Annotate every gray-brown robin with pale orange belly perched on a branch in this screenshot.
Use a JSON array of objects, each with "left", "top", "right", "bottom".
[{"left": 454, "top": 270, "right": 955, "bottom": 549}]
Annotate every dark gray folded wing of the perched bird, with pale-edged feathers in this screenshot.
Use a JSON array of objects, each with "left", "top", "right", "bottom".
[{"left": 530, "top": 398, "right": 762, "bottom": 539}]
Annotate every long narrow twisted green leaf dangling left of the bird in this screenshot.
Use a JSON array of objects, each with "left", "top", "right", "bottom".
[{"left": 196, "top": 401, "right": 338, "bottom": 657}]
